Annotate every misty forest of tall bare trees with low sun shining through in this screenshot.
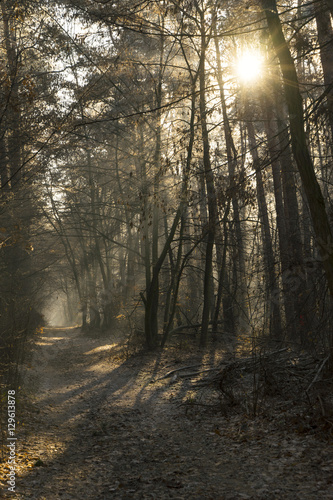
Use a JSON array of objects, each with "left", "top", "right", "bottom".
[{"left": 0, "top": 0, "right": 333, "bottom": 499}]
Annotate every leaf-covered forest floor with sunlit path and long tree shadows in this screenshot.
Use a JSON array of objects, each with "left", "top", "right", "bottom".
[{"left": 0, "top": 329, "right": 333, "bottom": 500}]
